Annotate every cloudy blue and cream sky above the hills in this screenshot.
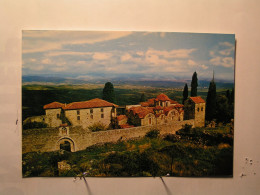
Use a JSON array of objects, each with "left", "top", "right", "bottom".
[{"left": 22, "top": 30, "right": 235, "bottom": 82}]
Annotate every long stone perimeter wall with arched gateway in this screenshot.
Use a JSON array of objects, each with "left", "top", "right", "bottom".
[{"left": 22, "top": 120, "right": 194, "bottom": 153}]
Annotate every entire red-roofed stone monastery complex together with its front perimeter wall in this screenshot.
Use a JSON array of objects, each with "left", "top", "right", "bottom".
[{"left": 22, "top": 94, "right": 206, "bottom": 153}]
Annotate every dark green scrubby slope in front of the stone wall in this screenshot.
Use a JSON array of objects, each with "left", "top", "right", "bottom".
[{"left": 23, "top": 126, "right": 233, "bottom": 177}]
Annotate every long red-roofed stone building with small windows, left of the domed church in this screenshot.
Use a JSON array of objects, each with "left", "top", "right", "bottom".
[{"left": 24, "top": 98, "right": 117, "bottom": 128}]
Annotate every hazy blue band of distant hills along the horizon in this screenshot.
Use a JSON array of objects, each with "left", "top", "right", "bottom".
[{"left": 22, "top": 76, "right": 234, "bottom": 88}]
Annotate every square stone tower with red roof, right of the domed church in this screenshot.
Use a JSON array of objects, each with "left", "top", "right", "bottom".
[{"left": 184, "top": 96, "right": 206, "bottom": 127}]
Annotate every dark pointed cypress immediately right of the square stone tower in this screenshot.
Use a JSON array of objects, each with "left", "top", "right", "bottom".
[{"left": 206, "top": 79, "right": 217, "bottom": 121}]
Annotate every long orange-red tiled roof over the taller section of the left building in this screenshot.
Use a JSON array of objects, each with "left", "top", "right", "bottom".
[{"left": 63, "top": 98, "right": 117, "bottom": 110}]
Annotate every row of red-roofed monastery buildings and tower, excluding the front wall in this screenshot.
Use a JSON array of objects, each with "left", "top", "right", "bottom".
[{"left": 24, "top": 94, "right": 205, "bottom": 129}]
